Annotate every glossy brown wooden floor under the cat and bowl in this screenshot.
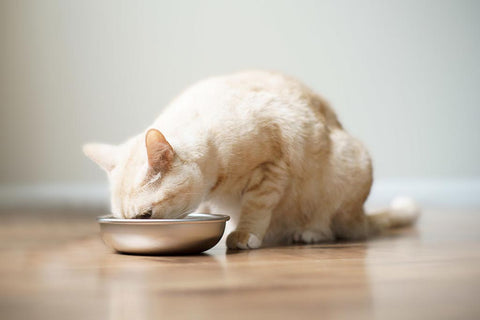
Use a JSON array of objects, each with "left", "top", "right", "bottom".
[{"left": 0, "top": 206, "right": 480, "bottom": 319}]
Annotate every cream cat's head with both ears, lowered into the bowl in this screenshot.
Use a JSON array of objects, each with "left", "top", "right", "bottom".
[{"left": 83, "top": 129, "right": 203, "bottom": 218}]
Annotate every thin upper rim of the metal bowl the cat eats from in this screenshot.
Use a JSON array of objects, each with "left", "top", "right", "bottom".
[{"left": 97, "top": 212, "right": 230, "bottom": 225}]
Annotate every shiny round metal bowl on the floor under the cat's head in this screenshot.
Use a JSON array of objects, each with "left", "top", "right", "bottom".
[{"left": 97, "top": 213, "right": 230, "bottom": 255}]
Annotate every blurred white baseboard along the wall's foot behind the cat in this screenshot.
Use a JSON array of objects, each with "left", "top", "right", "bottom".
[{"left": 0, "top": 178, "right": 480, "bottom": 208}]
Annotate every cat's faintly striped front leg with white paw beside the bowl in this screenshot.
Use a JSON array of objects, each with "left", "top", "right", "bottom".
[{"left": 227, "top": 162, "right": 287, "bottom": 249}]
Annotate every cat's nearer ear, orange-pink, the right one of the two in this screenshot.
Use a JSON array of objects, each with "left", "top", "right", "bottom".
[{"left": 145, "top": 129, "right": 174, "bottom": 172}]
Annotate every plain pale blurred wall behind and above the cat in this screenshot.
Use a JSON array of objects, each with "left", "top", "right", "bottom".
[{"left": 0, "top": 0, "right": 480, "bottom": 205}]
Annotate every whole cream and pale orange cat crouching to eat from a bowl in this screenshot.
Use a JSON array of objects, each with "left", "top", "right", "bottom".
[{"left": 84, "top": 71, "right": 418, "bottom": 249}]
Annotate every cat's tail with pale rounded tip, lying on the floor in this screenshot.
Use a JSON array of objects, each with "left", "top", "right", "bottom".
[{"left": 367, "top": 197, "right": 420, "bottom": 234}]
